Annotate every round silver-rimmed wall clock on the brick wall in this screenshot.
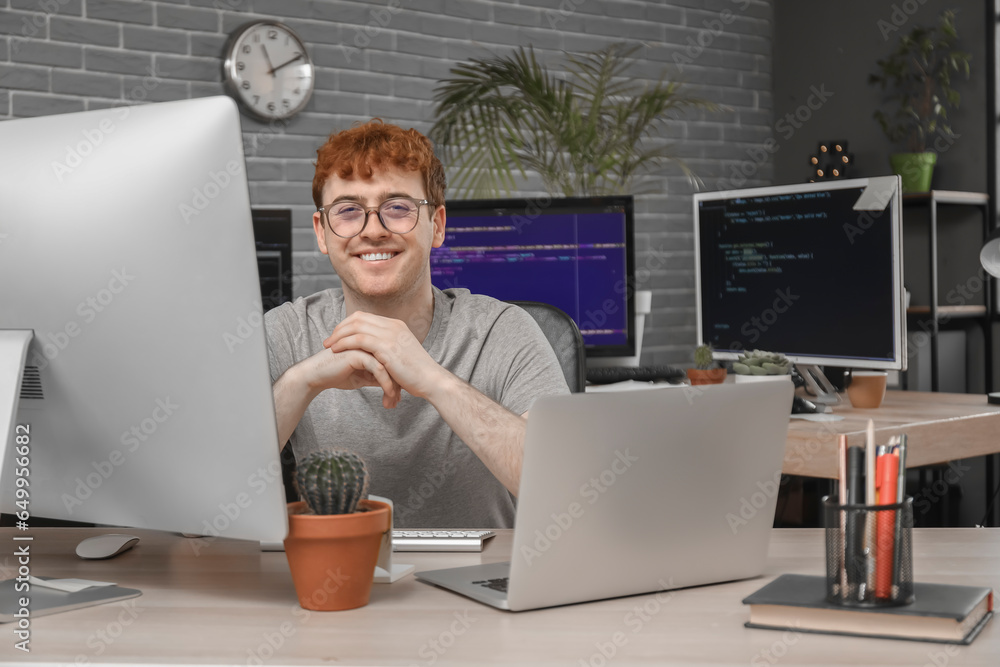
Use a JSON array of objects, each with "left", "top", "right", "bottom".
[{"left": 224, "top": 21, "right": 314, "bottom": 120}]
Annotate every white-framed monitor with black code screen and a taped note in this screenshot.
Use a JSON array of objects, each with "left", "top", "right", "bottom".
[{"left": 694, "top": 176, "right": 906, "bottom": 400}]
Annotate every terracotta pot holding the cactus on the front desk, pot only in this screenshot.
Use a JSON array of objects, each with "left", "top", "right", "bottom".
[{"left": 285, "top": 500, "right": 390, "bottom": 611}]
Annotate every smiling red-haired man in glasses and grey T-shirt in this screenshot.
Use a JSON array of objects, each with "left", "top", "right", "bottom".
[{"left": 265, "top": 120, "right": 568, "bottom": 528}]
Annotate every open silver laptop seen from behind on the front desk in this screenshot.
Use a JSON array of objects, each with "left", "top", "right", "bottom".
[{"left": 415, "top": 382, "right": 794, "bottom": 611}]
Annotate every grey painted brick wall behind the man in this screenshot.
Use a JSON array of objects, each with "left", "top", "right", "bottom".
[{"left": 0, "top": 0, "right": 773, "bottom": 364}]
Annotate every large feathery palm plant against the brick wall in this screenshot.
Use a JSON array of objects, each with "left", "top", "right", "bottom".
[{"left": 430, "top": 44, "right": 716, "bottom": 197}]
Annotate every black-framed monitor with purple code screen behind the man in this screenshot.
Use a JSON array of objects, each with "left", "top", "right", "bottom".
[{"left": 431, "top": 196, "right": 636, "bottom": 358}]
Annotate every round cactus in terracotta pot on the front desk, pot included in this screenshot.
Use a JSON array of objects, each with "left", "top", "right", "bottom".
[{"left": 285, "top": 450, "right": 392, "bottom": 611}]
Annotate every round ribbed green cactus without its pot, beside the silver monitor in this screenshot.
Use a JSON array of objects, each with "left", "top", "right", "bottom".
[{"left": 295, "top": 449, "right": 368, "bottom": 514}]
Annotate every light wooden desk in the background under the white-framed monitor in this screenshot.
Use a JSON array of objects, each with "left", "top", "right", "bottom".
[{"left": 782, "top": 391, "right": 1000, "bottom": 479}]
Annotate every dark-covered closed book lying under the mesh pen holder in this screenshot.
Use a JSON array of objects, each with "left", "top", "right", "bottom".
[{"left": 743, "top": 574, "right": 993, "bottom": 644}]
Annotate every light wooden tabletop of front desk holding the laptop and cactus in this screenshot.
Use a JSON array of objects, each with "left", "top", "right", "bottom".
[{"left": 0, "top": 528, "right": 1000, "bottom": 667}]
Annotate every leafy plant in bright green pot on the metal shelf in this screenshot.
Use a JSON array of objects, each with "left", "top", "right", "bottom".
[{"left": 868, "top": 10, "right": 972, "bottom": 192}]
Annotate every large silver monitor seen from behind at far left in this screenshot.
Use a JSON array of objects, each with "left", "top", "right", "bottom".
[{"left": 0, "top": 97, "right": 287, "bottom": 541}]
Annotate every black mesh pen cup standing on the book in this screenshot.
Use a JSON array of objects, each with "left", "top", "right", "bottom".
[{"left": 823, "top": 496, "right": 913, "bottom": 607}]
